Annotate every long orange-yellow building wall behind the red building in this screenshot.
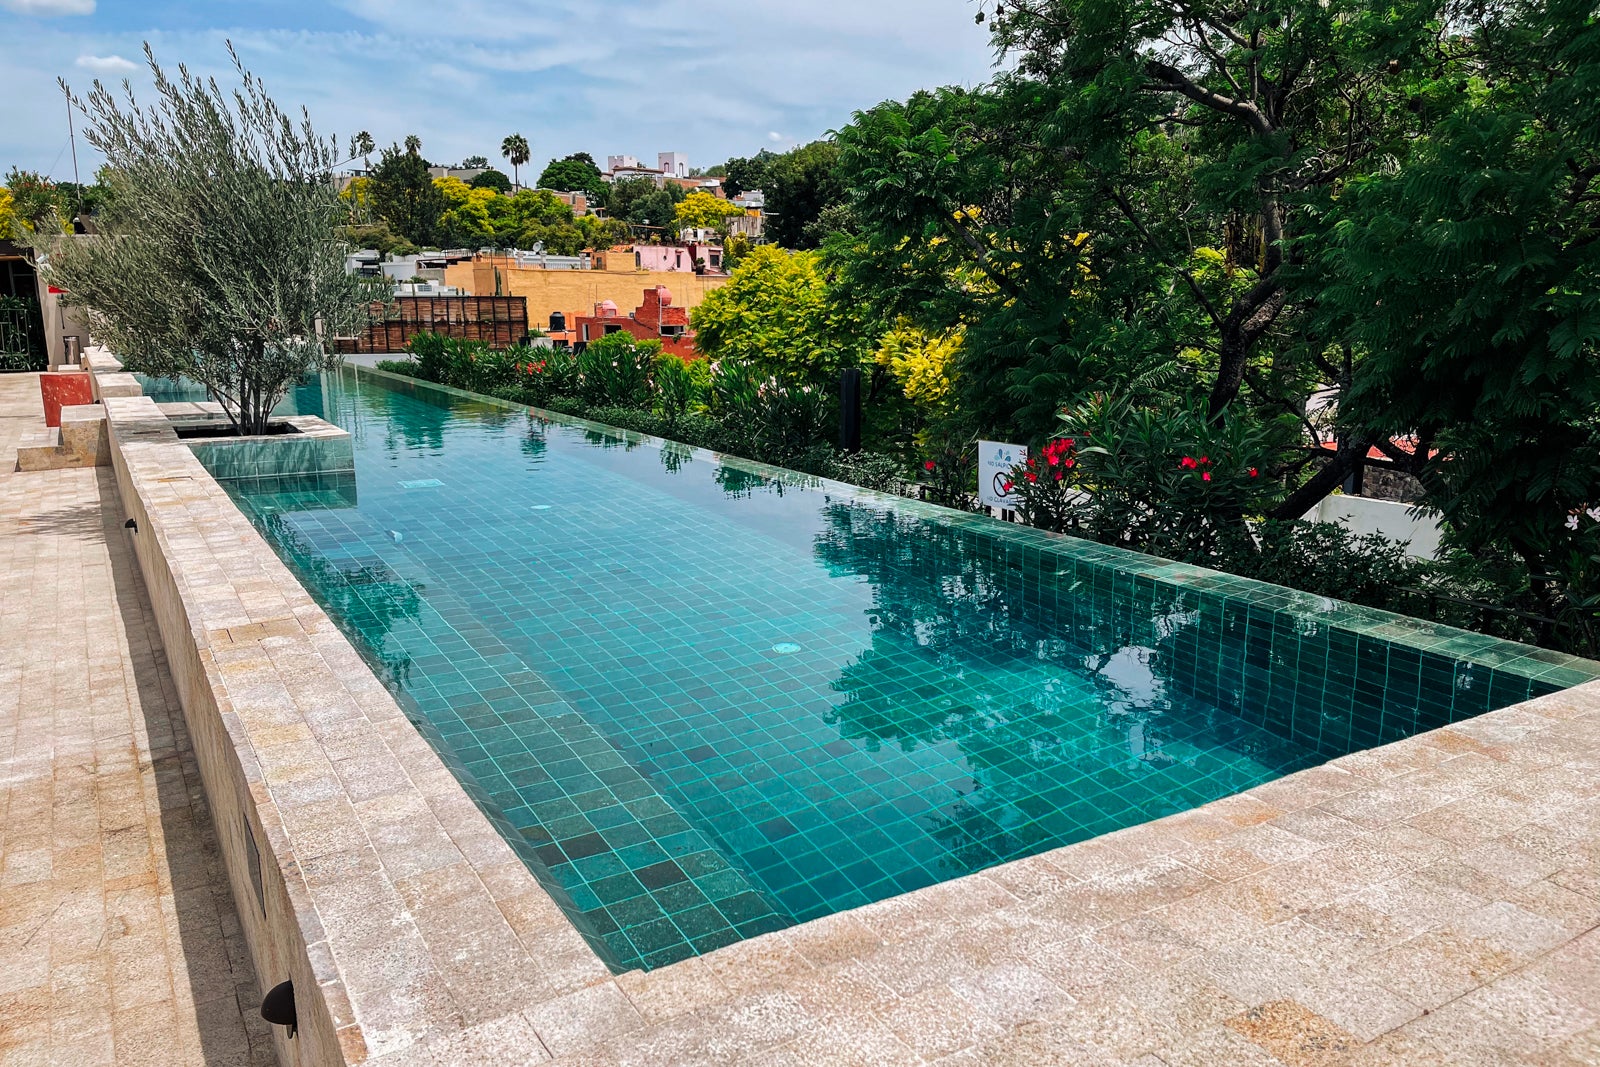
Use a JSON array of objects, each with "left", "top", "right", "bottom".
[{"left": 445, "top": 256, "right": 728, "bottom": 330}]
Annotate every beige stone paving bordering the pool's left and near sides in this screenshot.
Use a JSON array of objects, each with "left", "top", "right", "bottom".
[{"left": 93, "top": 355, "right": 1600, "bottom": 1067}]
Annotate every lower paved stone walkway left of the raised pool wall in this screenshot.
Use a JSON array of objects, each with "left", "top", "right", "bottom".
[{"left": 0, "top": 374, "right": 275, "bottom": 1067}]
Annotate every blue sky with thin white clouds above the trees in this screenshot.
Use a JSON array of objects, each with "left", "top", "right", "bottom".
[{"left": 0, "top": 0, "right": 992, "bottom": 179}]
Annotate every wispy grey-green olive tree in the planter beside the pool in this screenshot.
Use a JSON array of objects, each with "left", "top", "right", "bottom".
[{"left": 37, "top": 45, "right": 382, "bottom": 434}]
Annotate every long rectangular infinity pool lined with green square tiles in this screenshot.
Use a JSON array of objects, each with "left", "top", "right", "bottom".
[{"left": 206, "top": 370, "right": 1592, "bottom": 969}]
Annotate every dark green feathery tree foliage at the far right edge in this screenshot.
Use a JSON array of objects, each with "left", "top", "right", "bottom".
[{"left": 1307, "top": 0, "right": 1600, "bottom": 616}]
